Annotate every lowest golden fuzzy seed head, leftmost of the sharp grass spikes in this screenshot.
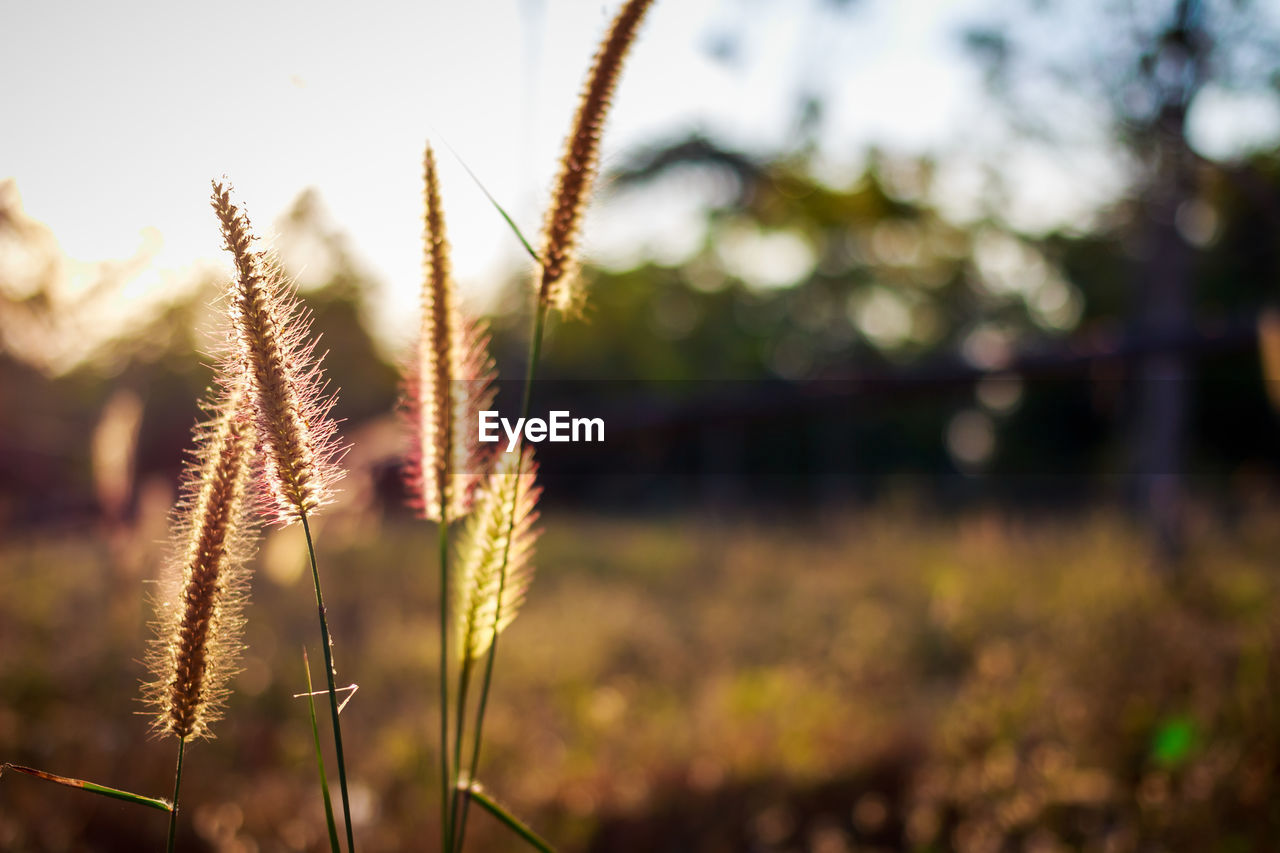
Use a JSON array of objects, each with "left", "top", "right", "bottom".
[{"left": 143, "top": 382, "right": 256, "bottom": 739}]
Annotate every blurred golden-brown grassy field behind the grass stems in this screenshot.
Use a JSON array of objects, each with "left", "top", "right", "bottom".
[{"left": 0, "top": 510, "right": 1280, "bottom": 853}]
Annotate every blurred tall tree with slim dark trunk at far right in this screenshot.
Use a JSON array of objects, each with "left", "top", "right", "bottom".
[{"left": 968, "top": 0, "right": 1280, "bottom": 565}]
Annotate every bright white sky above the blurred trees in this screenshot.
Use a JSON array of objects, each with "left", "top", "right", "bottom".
[{"left": 0, "top": 0, "right": 1280, "bottom": 348}]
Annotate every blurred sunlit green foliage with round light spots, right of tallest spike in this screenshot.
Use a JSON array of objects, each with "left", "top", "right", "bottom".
[{"left": 499, "top": 136, "right": 1082, "bottom": 379}]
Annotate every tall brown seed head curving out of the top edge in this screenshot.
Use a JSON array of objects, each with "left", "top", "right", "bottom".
[{"left": 538, "top": 0, "right": 653, "bottom": 311}]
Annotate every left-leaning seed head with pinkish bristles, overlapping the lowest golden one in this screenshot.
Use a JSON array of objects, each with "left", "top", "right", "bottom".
[{"left": 212, "top": 181, "right": 342, "bottom": 524}]
